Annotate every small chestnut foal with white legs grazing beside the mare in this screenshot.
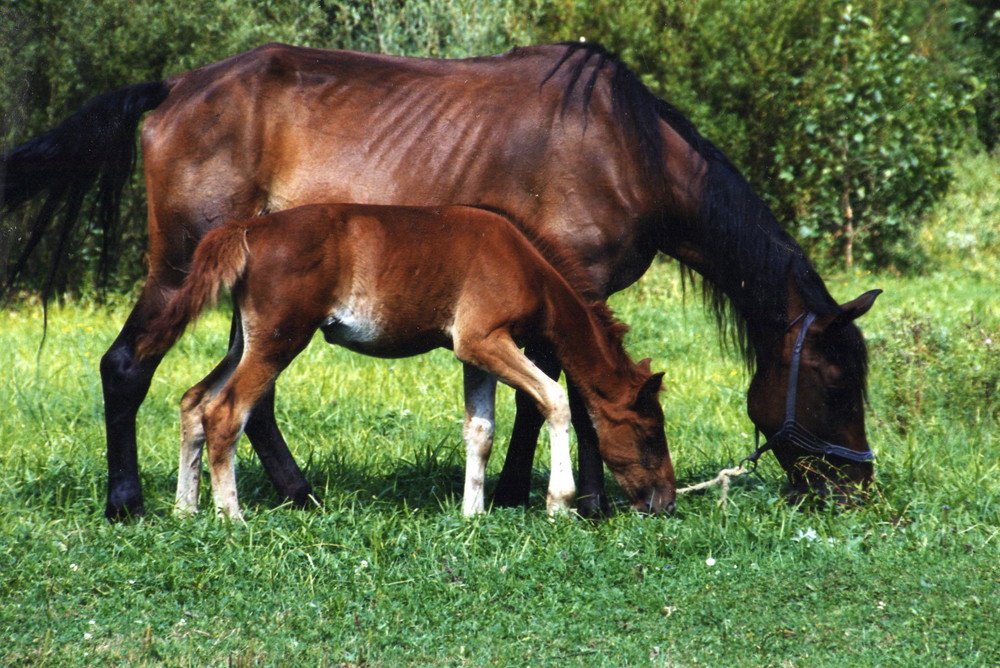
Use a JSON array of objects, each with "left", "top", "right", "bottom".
[{"left": 138, "top": 204, "right": 674, "bottom": 518}]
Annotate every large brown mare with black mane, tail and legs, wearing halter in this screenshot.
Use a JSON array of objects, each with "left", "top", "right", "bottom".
[{"left": 0, "top": 44, "right": 877, "bottom": 518}]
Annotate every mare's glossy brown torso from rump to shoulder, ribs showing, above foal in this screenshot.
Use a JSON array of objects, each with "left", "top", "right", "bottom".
[{"left": 137, "top": 44, "right": 649, "bottom": 292}]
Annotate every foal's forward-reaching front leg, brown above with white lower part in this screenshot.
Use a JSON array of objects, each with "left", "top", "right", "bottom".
[{"left": 455, "top": 332, "right": 576, "bottom": 513}]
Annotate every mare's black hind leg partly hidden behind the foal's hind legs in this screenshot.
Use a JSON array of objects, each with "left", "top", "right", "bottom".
[{"left": 229, "top": 305, "right": 315, "bottom": 508}]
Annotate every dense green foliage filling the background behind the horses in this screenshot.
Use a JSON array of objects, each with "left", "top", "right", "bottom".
[{"left": 0, "top": 0, "right": 1000, "bottom": 289}]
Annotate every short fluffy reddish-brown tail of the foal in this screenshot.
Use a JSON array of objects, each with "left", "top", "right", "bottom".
[{"left": 136, "top": 223, "right": 250, "bottom": 359}]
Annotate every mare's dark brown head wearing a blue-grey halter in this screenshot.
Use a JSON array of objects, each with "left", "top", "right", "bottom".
[{"left": 747, "top": 290, "right": 881, "bottom": 503}]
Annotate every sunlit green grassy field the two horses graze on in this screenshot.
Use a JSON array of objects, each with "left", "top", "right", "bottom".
[{"left": 0, "top": 157, "right": 1000, "bottom": 666}]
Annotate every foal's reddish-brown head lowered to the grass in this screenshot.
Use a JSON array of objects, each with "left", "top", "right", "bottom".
[{"left": 597, "top": 359, "right": 676, "bottom": 513}]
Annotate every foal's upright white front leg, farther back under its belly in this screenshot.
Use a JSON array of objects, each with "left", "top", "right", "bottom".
[{"left": 462, "top": 364, "right": 497, "bottom": 515}]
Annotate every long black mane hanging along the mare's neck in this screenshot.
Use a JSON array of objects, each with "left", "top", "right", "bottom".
[{"left": 545, "top": 42, "right": 866, "bottom": 384}]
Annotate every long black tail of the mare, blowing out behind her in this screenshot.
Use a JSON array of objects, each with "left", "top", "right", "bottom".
[{"left": 0, "top": 81, "right": 170, "bottom": 303}]
